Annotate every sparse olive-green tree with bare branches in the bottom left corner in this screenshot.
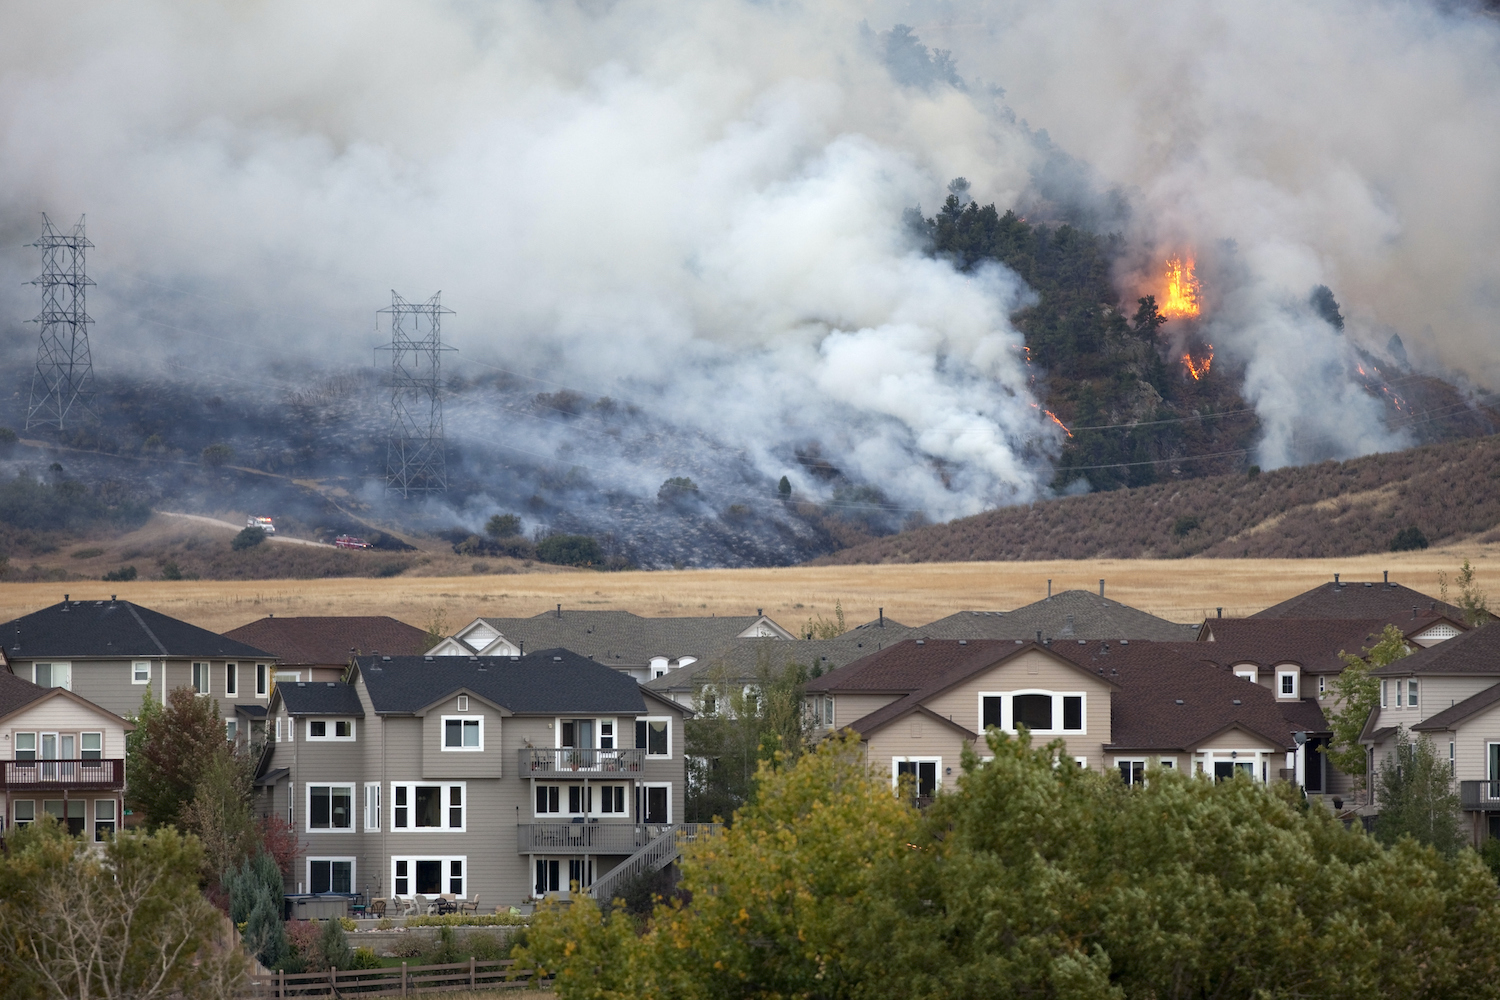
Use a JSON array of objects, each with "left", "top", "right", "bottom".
[{"left": 0, "top": 822, "right": 246, "bottom": 1000}]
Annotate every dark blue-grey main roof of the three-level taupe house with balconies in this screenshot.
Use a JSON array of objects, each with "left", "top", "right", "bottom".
[{"left": 364, "top": 649, "right": 645, "bottom": 715}]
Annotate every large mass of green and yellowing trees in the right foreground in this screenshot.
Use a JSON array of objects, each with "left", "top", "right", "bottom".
[{"left": 516, "top": 732, "right": 1500, "bottom": 1000}]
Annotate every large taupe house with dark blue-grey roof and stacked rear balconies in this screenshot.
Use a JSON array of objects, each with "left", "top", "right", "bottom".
[{"left": 257, "top": 649, "right": 686, "bottom": 909}]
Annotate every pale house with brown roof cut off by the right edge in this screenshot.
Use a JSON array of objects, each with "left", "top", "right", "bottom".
[{"left": 1361, "top": 625, "right": 1500, "bottom": 846}]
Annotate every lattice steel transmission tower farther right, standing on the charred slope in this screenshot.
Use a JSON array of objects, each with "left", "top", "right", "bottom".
[{"left": 380, "top": 291, "right": 455, "bottom": 496}]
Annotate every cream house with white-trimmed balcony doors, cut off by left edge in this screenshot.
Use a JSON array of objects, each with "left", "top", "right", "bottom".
[{"left": 0, "top": 672, "right": 134, "bottom": 841}]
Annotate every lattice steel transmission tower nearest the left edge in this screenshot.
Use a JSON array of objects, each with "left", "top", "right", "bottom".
[{"left": 26, "top": 214, "right": 93, "bottom": 430}]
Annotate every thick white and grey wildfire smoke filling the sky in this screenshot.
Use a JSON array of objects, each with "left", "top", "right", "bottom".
[{"left": 0, "top": 0, "right": 1500, "bottom": 517}]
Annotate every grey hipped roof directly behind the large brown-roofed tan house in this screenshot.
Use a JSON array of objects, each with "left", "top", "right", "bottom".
[{"left": 914, "top": 591, "right": 1199, "bottom": 642}]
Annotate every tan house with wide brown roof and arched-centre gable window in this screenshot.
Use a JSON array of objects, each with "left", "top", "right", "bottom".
[{"left": 807, "top": 639, "right": 1326, "bottom": 798}]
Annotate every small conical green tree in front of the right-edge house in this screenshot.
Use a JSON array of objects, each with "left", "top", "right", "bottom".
[{"left": 1376, "top": 729, "right": 1464, "bottom": 855}]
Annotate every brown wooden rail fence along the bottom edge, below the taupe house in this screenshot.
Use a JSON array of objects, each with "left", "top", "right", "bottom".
[{"left": 248, "top": 958, "right": 537, "bottom": 1000}]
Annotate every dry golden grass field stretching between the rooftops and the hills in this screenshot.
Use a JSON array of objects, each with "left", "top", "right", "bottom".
[{"left": 0, "top": 544, "right": 1500, "bottom": 631}]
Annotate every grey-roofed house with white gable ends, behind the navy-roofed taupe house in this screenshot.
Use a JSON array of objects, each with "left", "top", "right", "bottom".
[{"left": 428, "top": 604, "right": 794, "bottom": 684}]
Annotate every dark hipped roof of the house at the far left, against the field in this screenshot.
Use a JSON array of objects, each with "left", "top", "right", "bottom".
[{"left": 0, "top": 601, "right": 276, "bottom": 660}]
